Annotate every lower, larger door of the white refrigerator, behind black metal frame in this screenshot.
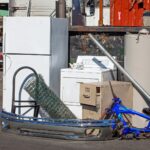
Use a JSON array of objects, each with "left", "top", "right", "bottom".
[{"left": 3, "top": 55, "right": 51, "bottom": 112}]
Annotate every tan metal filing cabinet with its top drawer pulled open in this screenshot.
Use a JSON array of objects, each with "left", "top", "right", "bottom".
[{"left": 80, "top": 81, "right": 133, "bottom": 119}]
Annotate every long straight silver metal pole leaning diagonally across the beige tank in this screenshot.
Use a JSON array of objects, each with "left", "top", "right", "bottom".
[{"left": 89, "top": 34, "right": 150, "bottom": 105}]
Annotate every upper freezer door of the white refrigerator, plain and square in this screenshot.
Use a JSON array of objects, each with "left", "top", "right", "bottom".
[{"left": 3, "top": 17, "right": 51, "bottom": 55}]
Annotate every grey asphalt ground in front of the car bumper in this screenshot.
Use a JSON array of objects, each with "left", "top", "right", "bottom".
[{"left": 0, "top": 72, "right": 150, "bottom": 150}]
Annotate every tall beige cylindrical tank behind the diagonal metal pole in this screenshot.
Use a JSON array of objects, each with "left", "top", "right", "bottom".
[{"left": 124, "top": 29, "right": 150, "bottom": 128}]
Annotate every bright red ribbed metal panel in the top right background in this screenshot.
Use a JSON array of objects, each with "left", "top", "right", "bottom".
[{"left": 110, "top": 0, "right": 150, "bottom": 26}]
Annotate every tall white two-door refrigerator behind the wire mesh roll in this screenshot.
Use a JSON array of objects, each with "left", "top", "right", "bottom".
[{"left": 3, "top": 17, "right": 68, "bottom": 115}]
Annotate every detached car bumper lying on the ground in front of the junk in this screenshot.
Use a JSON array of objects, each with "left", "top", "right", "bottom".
[{"left": 0, "top": 111, "right": 114, "bottom": 140}]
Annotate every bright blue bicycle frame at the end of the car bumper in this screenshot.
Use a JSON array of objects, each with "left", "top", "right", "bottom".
[{"left": 108, "top": 98, "right": 150, "bottom": 137}]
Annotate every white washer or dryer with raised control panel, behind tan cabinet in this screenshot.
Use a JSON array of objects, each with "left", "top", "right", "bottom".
[{"left": 60, "top": 56, "right": 117, "bottom": 119}]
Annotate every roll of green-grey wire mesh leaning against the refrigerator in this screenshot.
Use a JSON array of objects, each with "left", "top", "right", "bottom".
[{"left": 24, "top": 75, "right": 76, "bottom": 119}]
